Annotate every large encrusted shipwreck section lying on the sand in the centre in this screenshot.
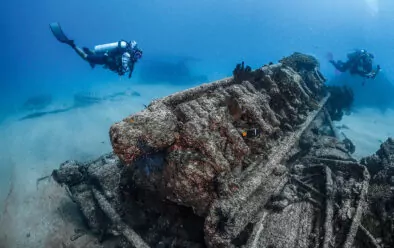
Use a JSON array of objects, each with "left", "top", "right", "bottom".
[{"left": 53, "top": 53, "right": 379, "bottom": 248}]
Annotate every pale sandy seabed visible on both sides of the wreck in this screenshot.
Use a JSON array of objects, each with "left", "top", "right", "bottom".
[{"left": 0, "top": 83, "right": 394, "bottom": 248}]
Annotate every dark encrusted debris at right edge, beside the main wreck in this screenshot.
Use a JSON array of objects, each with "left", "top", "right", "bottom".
[{"left": 361, "top": 138, "right": 394, "bottom": 247}]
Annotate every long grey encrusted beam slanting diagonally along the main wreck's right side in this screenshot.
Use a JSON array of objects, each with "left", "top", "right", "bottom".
[{"left": 205, "top": 92, "right": 329, "bottom": 247}]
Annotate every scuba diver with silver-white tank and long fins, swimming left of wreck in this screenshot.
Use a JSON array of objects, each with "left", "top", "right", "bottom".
[{"left": 49, "top": 22, "right": 142, "bottom": 78}]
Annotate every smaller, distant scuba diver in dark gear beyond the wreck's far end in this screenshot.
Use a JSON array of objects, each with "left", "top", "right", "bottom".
[{"left": 329, "top": 49, "right": 381, "bottom": 79}]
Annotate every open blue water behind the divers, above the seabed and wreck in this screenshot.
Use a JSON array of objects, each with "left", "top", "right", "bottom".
[{"left": 0, "top": 0, "right": 394, "bottom": 114}]
